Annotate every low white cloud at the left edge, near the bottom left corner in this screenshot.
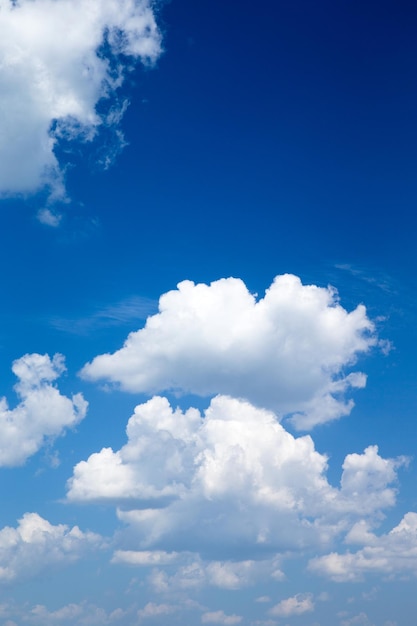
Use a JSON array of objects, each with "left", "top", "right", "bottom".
[{"left": 0, "top": 513, "right": 102, "bottom": 582}]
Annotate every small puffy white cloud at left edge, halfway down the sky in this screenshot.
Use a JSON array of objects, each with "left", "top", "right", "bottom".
[{"left": 0, "top": 354, "right": 88, "bottom": 467}]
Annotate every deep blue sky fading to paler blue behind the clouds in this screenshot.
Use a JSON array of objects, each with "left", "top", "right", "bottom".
[{"left": 0, "top": 0, "right": 417, "bottom": 626}]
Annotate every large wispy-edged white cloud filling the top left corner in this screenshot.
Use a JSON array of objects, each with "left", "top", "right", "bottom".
[{"left": 0, "top": 0, "right": 160, "bottom": 197}]
